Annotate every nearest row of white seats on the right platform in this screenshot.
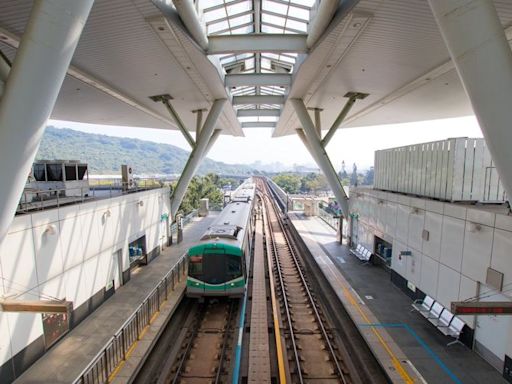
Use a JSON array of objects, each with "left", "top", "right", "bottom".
[{"left": 411, "top": 295, "right": 465, "bottom": 346}]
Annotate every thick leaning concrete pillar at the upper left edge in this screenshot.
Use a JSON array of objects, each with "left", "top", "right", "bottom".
[{"left": 0, "top": 0, "right": 94, "bottom": 241}]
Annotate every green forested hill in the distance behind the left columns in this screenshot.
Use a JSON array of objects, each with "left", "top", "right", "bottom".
[{"left": 36, "top": 126, "right": 252, "bottom": 175}]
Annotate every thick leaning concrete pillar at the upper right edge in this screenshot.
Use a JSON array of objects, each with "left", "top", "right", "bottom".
[{"left": 429, "top": 0, "right": 512, "bottom": 198}]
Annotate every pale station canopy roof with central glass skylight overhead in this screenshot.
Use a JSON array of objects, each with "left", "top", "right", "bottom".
[{"left": 0, "top": 0, "right": 512, "bottom": 136}]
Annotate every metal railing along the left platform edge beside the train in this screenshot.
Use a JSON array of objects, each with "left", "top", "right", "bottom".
[{"left": 73, "top": 255, "right": 187, "bottom": 384}]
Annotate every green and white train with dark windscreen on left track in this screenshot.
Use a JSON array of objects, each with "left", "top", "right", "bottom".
[{"left": 186, "top": 179, "right": 256, "bottom": 298}]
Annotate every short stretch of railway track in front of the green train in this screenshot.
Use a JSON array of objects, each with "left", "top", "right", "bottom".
[{"left": 169, "top": 300, "right": 239, "bottom": 384}]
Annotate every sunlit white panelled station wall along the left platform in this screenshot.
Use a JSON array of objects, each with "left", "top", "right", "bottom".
[{"left": 0, "top": 188, "right": 170, "bottom": 382}]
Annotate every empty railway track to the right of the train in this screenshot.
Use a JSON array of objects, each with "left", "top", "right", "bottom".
[{"left": 259, "top": 181, "right": 359, "bottom": 384}]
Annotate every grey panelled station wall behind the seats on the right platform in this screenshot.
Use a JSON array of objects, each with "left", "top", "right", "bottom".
[{"left": 350, "top": 188, "right": 512, "bottom": 368}]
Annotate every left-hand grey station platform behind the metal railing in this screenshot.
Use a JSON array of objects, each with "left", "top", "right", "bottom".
[{"left": 15, "top": 212, "right": 215, "bottom": 384}]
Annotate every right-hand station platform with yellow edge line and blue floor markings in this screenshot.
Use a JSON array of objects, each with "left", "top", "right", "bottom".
[{"left": 289, "top": 212, "right": 506, "bottom": 384}]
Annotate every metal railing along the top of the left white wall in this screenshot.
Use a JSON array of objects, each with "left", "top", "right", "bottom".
[{"left": 16, "top": 179, "right": 165, "bottom": 214}]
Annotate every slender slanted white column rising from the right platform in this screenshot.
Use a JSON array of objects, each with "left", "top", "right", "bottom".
[{"left": 291, "top": 99, "right": 349, "bottom": 217}]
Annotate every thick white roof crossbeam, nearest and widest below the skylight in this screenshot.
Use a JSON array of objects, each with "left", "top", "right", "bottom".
[{"left": 207, "top": 33, "right": 308, "bottom": 55}]
